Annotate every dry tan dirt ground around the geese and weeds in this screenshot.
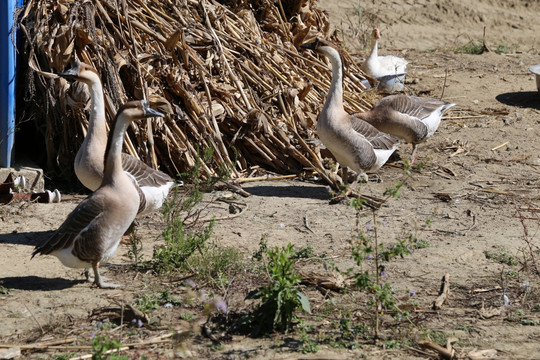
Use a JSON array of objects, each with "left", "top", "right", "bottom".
[{"left": 0, "top": 0, "right": 540, "bottom": 359}]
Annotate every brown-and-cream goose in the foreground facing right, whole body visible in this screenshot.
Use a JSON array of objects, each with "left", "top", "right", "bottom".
[{"left": 32, "top": 100, "right": 163, "bottom": 288}]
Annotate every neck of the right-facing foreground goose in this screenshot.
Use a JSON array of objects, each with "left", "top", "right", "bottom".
[{"left": 102, "top": 114, "right": 129, "bottom": 184}]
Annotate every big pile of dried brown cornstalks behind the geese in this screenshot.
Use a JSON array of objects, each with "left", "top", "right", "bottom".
[{"left": 19, "top": 0, "right": 370, "bottom": 190}]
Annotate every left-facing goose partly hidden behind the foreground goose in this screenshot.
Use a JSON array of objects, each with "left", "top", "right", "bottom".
[{"left": 58, "top": 61, "right": 174, "bottom": 215}]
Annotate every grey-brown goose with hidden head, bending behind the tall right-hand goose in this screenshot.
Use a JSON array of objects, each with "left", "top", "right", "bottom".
[{"left": 354, "top": 95, "right": 456, "bottom": 164}]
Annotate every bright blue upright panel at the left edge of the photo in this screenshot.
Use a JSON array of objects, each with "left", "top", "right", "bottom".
[{"left": 0, "top": 0, "right": 23, "bottom": 167}]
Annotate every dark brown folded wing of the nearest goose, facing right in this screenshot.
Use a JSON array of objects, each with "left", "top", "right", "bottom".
[{"left": 32, "top": 193, "right": 104, "bottom": 257}]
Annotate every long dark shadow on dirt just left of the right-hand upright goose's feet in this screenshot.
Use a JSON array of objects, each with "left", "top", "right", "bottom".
[{"left": 244, "top": 185, "right": 331, "bottom": 200}]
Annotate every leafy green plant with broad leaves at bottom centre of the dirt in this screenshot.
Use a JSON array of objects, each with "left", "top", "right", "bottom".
[{"left": 246, "top": 243, "right": 311, "bottom": 335}]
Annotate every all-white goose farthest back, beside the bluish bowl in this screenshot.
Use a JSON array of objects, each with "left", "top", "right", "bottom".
[{"left": 360, "top": 29, "right": 408, "bottom": 91}]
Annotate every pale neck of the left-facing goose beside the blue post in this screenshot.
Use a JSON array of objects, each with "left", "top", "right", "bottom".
[{"left": 85, "top": 74, "right": 107, "bottom": 142}]
